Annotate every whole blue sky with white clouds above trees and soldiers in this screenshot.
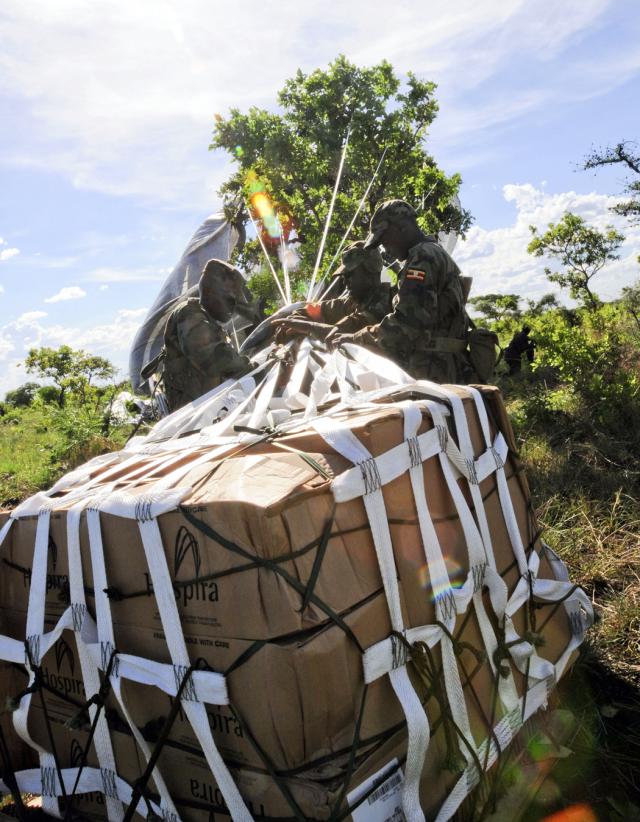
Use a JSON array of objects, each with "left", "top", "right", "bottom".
[{"left": 0, "top": 0, "right": 640, "bottom": 396}]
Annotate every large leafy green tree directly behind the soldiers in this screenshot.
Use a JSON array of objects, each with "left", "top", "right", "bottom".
[{"left": 210, "top": 56, "right": 471, "bottom": 286}]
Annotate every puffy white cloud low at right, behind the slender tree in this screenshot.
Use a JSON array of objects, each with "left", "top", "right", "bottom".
[{"left": 454, "top": 183, "right": 640, "bottom": 301}]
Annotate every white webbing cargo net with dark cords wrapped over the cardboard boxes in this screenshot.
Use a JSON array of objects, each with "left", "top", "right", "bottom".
[{"left": 0, "top": 340, "right": 593, "bottom": 822}]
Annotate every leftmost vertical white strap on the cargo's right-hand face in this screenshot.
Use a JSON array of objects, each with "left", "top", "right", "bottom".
[{"left": 313, "top": 418, "right": 430, "bottom": 822}]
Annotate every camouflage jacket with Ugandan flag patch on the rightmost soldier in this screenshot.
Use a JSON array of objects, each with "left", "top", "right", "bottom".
[{"left": 354, "top": 239, "right": 471, "bottom": 382}]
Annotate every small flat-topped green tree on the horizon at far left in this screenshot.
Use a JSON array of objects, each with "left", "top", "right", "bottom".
[{"left": 25, "top": 345, "right": 115, "bottom": 408}]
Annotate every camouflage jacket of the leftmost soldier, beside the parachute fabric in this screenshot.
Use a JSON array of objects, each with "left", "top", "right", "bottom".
[{"left": 164, "top": 298, "right": 251, "bottom": 411}]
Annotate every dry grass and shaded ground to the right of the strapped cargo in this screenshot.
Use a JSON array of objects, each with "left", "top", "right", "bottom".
[{"left": 503, "top": 375, "right": 640, "bottom": 822}]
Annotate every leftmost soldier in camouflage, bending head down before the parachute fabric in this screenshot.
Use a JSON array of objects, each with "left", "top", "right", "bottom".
[{"left": 162, "top": 260, "right": 251, "bottom": 411}]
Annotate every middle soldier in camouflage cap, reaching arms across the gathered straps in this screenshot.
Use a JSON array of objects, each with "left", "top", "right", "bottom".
[{"left": 274, "top": 240, "right": 392, "bottom": 341}]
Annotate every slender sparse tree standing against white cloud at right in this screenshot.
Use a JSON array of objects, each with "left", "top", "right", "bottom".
[{"left": 527, "top": 212, "right": 624, "bottom": 311}]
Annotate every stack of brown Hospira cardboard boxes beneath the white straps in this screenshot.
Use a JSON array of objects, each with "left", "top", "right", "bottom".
[{"left": 0, "top": 391, "right": 570, "bottom": 820}]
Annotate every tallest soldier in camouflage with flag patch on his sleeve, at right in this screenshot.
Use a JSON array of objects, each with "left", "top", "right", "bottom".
[{"left": 334, "top": 200, "right": 474, "bottom": 383}]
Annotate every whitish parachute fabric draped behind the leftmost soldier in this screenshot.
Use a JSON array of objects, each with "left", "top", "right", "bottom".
[{"left": 129, "top": 212, "right": 238, "bottom": 391}]
